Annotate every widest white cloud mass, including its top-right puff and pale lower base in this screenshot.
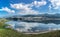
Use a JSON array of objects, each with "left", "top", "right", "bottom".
[{"left": 10, "top": 0, "right": 46, "bottom": 15}]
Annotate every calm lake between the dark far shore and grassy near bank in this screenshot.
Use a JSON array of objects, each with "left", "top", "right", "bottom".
[{"left": 6, "top": 21, "right": 60, "bottom": 32}]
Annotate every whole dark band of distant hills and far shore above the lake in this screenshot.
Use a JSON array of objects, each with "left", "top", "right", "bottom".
[{"left": 3, "top": 14, "right": 60, "bottom": 24}]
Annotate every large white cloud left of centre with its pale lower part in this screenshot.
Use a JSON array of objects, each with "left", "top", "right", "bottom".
[{"left": 11, "top": 3, "right": 39, "bottom": 15}]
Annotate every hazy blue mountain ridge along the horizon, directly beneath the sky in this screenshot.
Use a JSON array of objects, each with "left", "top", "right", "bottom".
[{"left": 3, "top": 14, "right": 60, "bottom": 18}]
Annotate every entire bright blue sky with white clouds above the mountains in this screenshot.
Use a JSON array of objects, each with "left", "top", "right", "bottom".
[{"left": 0, "top": 0, "right": 60, "bottom": 17}]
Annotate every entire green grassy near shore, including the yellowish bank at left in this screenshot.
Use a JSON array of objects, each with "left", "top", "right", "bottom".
[{"left": 0, "top": 19, "right": 60, "bottom": 37}]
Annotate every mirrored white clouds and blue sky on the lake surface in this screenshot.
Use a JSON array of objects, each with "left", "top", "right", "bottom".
[{"left": 7, "top": 21, "right": 60, "bottom": 31}]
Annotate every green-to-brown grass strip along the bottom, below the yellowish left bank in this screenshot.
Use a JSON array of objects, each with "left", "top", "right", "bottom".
[{"left": 0, "top": 29, "right": 60, "bottom": 37}]
